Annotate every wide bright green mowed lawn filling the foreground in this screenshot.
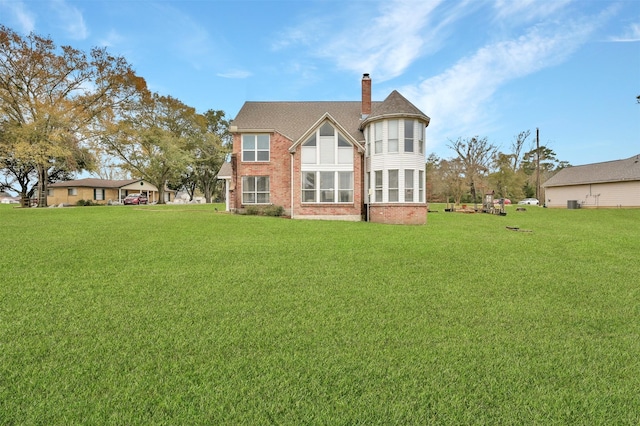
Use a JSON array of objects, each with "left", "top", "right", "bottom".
[{"left": 0, "top": 205, "right": 640, "bottom": 425}]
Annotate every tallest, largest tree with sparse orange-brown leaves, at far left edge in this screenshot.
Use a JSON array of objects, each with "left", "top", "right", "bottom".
[{"left": 0, "top": 25, "right": 146, "bottom": 207}]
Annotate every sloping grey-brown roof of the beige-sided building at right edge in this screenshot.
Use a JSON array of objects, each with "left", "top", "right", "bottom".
[{"left": 542, "top": 155, "right": 640, "bottom": 188}]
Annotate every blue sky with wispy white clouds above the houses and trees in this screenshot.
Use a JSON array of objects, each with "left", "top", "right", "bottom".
[{"left": 0, "top": 0, "right": 640, "bottom": 165}]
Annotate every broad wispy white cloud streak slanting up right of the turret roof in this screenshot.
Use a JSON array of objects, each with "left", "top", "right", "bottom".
[{"left": 408, "top": 15, "right": 598, "bottom": 150}]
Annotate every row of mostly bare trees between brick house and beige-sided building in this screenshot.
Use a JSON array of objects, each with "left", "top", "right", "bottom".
[{"left": 426, "top": 130, "right": 570, "bottom": 204}]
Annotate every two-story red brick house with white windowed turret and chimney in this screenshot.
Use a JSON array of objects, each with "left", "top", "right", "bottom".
[{"left": 224, "top": 74, "right": 430, "bottom": 224}]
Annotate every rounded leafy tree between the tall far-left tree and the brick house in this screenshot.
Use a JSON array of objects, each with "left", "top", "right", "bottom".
[{"left": 101, "top": 93, "right": 201, "bottom": 203}]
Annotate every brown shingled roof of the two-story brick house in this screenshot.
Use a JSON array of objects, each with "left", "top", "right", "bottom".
[{"left": 231, "top": 90, "right": 429, "bottom": 143}]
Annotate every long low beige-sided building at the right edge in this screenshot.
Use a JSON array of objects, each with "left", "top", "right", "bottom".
[{"left": 542, "top": 155, "right": 640, "bottom": 208}]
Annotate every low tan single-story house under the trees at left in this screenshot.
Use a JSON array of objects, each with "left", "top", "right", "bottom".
[{"left": 47, "top": 178, "right": 175, "bottom": 205}]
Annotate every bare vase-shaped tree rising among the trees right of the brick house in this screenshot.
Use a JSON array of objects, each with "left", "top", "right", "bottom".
[{"left": 448, "top": 136, "right": 497, "bottom": 203}]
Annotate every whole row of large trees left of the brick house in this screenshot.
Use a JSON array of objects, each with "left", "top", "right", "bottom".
[{"left": 0, "top": 25, "right": 231, "bottom": 207}]
